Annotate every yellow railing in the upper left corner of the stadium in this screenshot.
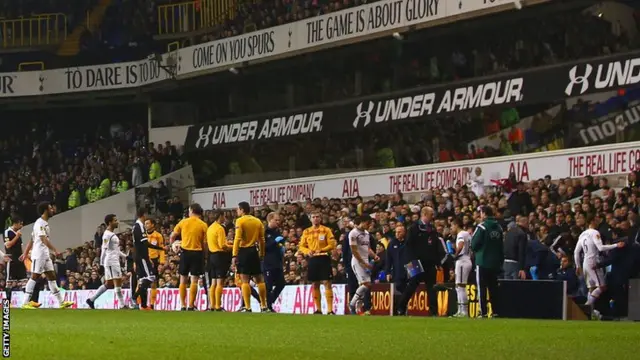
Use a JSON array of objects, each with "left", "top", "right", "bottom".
[{"left": 0, "top": 13, "right": 67, "bottom": 48}]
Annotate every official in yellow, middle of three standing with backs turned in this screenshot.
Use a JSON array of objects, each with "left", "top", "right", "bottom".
[{"left": 207, "top": 210, "right": 233, "bottom": 311}]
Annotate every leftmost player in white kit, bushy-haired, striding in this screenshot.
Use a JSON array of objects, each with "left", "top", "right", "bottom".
[{"left": 22, "top": 201, "right": 74, "bottom": 309}]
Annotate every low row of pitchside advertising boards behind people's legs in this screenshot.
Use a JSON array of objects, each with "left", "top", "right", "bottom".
[{"left": 0, "top": 280, "right": 573, "bottom": 320}]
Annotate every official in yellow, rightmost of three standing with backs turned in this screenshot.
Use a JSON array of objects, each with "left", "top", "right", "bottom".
[{"left": 233, "top": 201, "right": 269, "bottom": 312}]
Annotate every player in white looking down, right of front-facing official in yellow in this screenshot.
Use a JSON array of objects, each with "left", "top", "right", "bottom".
[{"left": 349, "top": 216, "right": 377, "bottom": 314}]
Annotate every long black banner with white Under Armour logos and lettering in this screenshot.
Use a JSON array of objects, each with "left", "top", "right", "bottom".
[{"left": 185, "top": 53, "right": 640, "bottom": 151}]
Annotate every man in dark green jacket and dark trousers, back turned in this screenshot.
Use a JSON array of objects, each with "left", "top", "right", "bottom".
[{"left": 471, "top": 206, "right": 504, "bottom": 317}]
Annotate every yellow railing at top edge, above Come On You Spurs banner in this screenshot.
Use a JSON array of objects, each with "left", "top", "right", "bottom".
[{"left": 158, "top": 0, "right": 237, "bottom": 35}]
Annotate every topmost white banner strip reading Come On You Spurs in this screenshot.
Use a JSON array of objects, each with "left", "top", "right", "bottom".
[{"left": 0, "top": 0, "right": 520, "bottom": 98}]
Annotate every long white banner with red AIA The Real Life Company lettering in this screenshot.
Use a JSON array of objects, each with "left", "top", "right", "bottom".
[{"left": 192, "top": 142, "right": 640, "bottom": 209}]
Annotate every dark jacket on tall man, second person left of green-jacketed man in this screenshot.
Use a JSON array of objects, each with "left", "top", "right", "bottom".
[{"left": 405, "top": 221, "right": 445, "bottom": 268}]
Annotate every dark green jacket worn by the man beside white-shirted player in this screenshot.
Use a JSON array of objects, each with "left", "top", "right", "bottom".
[{"left": 471, "top": 217, "right": 504, "bottom": 270}]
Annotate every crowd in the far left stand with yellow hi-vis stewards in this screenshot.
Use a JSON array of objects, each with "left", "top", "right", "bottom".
[{"left": 0, "top": 105, "right": 181, "bottom": 228}]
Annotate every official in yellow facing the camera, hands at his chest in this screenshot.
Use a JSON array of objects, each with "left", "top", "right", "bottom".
[{"left": 298, "top": 213, "right": 336, "bottom": 315}]
